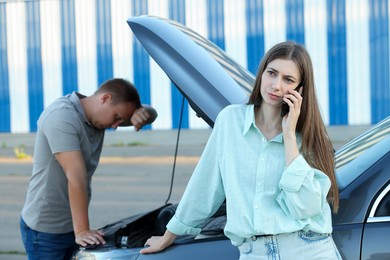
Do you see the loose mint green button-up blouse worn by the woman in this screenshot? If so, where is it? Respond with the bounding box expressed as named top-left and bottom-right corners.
top-left (167, 104), bottom-right (332, 246)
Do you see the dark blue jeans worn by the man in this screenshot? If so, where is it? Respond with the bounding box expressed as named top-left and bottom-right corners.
top-left (20, 218), bottom-right (78, 260)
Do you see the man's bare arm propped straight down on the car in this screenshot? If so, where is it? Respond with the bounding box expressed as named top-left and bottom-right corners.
top-left (55, 151), bottom-right (105, 246)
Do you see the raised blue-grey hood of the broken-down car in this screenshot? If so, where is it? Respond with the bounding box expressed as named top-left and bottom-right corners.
top-left (127, 16), bottom-right (254, 127)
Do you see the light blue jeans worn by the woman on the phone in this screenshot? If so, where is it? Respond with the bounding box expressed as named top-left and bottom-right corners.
top-left (238, 231), bottom-right (342, 260)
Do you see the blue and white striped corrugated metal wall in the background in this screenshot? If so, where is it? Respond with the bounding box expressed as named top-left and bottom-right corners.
top-left (0, 0), bottom-right (390, 133)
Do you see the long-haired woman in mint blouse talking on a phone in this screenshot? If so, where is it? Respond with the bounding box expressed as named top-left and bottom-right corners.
top-left (141, 42), bottom-right (341, 259)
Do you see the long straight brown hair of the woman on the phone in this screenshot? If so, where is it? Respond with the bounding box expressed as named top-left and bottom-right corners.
top-left (248, 41), bottom-right (339, 212)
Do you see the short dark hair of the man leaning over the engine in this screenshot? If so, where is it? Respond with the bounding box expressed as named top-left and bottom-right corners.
top-left (95, 78), bottom-right (141, 108)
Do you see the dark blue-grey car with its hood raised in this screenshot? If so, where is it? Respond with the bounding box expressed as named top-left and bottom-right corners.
top-left (74, 16), bottom-right (390, 260)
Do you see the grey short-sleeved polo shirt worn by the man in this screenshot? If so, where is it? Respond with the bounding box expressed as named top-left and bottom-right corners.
top-left (22, 92), bottom-right (104, 234)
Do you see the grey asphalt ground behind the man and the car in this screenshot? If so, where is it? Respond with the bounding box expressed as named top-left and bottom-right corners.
top-left (0, 126), bottom-right (369, 260)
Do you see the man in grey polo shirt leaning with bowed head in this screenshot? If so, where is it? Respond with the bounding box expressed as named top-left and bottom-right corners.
top-left (20, 79), bottom-right (157, 259)
